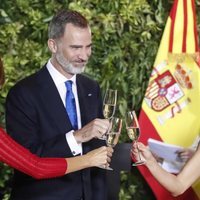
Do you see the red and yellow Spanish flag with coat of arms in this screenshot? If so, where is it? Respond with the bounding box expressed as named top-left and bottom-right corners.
top-left (138, 0), bottom-right (200, 200)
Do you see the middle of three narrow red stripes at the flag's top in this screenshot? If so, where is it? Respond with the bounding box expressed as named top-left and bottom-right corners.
top-left (182, 0), bottom-right (188, 53)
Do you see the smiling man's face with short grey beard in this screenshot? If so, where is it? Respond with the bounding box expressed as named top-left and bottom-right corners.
top-left (55, 24), bottom-right (92, 75)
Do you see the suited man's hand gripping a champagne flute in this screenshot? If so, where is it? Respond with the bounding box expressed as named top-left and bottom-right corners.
top-left (74, 119), bottom-right (109, 143)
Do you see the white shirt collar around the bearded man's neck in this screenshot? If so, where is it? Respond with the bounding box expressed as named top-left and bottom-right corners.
top-left (47, 59), bottom-right (76, 86)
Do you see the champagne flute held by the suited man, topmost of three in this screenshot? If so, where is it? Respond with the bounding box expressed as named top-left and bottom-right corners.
top-left (99, 89), bottom-right (117, 140)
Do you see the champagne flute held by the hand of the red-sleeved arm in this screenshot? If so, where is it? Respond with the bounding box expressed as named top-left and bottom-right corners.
top-left (105, 117), bottom-right (122, 170)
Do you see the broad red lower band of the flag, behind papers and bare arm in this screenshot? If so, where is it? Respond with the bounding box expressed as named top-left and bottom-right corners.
top-left (138, 109), bottom-right (199, 200)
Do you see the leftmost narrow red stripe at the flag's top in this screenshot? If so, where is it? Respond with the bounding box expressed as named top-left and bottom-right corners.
top-left (169, 0), bottom-right (178, 53)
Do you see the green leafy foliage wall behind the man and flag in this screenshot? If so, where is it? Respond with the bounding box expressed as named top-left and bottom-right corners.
top-left (0, 0), bottom-right (200, 200)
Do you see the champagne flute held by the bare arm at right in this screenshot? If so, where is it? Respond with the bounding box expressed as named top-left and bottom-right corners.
top-left (126, 111), bottom-right (144, 166)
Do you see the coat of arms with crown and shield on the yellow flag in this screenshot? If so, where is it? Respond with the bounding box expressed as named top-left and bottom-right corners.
top-left (144, 62), bottom-right (194, 125)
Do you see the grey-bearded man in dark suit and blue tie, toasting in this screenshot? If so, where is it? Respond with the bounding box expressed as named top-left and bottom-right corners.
top-left (6, 10), bottom-right (109, 200)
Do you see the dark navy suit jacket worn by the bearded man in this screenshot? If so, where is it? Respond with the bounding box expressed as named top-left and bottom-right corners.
top-left (6, 66), bottom-right (106, 200)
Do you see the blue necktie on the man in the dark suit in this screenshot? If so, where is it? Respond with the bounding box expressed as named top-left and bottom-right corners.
top-left (65, 81), bottom-right (78, 130)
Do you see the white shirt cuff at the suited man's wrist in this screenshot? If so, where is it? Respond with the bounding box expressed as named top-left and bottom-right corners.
top-left (65, 130), bottom-right (83, 156)
